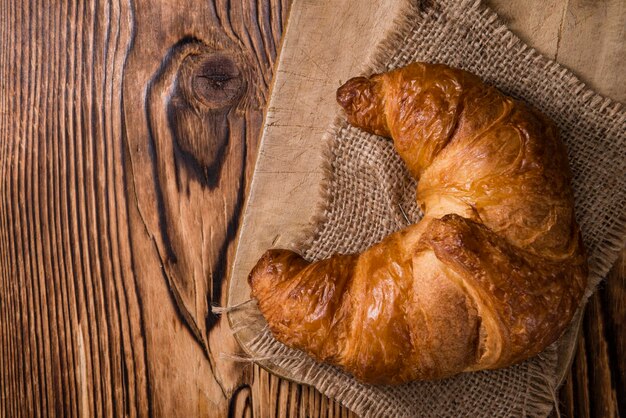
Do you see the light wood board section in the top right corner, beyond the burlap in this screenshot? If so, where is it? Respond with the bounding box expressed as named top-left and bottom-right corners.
top-left (485, 0), bottom-right (626, 103)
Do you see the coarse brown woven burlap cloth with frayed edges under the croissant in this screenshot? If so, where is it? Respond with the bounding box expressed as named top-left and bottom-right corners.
top-left (235, 1), bottom-right (626, 417)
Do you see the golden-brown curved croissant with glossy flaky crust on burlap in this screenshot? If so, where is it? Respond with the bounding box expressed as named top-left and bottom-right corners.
top-left (248, 63), bottom-right (587, 384)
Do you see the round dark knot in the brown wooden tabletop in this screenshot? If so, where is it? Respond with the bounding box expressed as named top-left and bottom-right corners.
top-left (182, 52), bottom-right (246, 109)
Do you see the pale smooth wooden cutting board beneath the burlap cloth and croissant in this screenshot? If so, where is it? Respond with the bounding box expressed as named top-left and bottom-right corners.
top-left (229, 0), bottom-right (626, 414)
